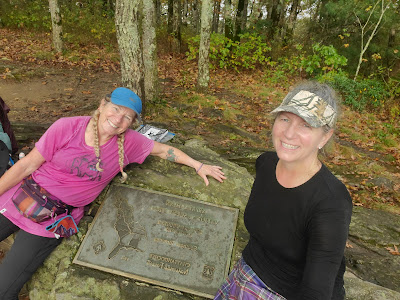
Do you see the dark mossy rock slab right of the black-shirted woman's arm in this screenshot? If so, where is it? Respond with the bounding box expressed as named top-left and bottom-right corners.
top-left (345, 206), bottom-right (400, 292)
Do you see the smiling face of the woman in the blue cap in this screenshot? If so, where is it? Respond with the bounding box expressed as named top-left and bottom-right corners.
top-left (98, 100), bottom-right (136, 139)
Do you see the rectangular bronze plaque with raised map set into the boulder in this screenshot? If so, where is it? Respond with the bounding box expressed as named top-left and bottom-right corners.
top-left (74, 185), bottom-right (238, 298)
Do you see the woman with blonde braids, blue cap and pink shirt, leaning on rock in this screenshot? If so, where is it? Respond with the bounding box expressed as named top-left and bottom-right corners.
top-left (0, 87), bottom-right (225, 300)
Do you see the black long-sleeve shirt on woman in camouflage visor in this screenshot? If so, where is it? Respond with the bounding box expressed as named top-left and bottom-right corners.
top-left (243, 152), bottom-right (352, 300)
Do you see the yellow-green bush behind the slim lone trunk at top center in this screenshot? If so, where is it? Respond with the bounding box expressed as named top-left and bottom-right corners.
top-left (186, 33), bottom-right (271, 71)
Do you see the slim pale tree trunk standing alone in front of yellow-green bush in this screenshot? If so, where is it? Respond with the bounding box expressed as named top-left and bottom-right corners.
top-left (197, 0), bottom-right (213, 93)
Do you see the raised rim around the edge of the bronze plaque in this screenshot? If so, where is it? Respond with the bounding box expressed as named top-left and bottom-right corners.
top-left (72, 183), bottom-right (239, 299)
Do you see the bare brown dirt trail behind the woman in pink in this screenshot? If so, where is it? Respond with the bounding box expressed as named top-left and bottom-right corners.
top-left (0, 63), bottom-right (120, 124)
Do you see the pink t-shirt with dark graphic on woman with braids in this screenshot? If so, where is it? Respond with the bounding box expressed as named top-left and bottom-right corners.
top-left (0, 117), bottom-right (154, 237)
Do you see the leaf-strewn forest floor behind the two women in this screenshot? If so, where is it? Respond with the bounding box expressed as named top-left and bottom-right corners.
top-left (0, 29), bottom-right (400, 219)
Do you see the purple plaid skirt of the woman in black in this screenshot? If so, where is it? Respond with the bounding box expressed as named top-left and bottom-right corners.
top-left (214, 257), bottom-right (286, 300)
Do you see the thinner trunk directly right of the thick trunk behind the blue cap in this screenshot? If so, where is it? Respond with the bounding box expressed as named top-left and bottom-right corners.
top-left (143, 0), bottom-right (158, 101)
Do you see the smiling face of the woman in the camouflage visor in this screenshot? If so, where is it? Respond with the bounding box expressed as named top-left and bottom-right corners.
top-left (272, 112), bottom-right (333, 165)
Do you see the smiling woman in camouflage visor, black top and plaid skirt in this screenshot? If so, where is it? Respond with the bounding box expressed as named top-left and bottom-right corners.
top-left (215, 82), bottom-right (352, 300)
